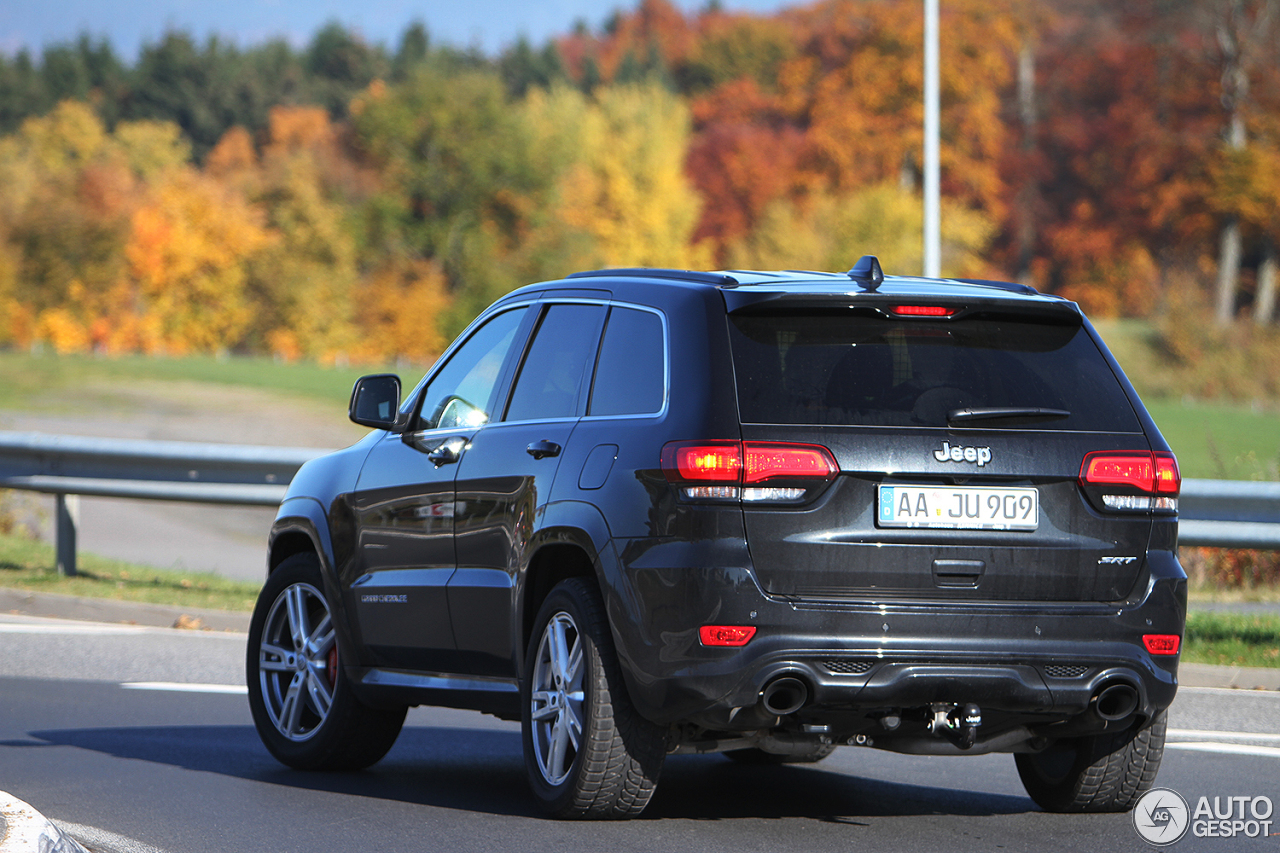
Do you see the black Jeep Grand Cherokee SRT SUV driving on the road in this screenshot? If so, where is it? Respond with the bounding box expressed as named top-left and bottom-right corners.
top-left (247, 256), bottom-right (1187, 817)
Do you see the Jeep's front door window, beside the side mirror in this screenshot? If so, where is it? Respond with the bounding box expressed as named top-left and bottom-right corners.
top-left (417, 309), bottom-right (525, 429)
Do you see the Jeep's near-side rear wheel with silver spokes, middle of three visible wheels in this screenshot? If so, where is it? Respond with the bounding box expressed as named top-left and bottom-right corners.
top-left (521, 578), bottom-right (667, 820)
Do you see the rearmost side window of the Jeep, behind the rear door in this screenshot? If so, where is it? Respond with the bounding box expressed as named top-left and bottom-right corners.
top-left (588, 307), bottom-right (667, 415)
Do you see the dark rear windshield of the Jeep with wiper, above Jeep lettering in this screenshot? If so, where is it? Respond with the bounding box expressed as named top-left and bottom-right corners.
top-left (730, 311), bottom-right (1142, 432)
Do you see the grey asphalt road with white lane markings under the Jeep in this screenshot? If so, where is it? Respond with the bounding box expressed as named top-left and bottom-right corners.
top-left (0, 616), bottom-right (1280, 853)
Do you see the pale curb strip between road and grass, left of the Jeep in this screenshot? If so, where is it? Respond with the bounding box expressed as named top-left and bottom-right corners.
top-left (0, 588), bottom-right (250, 634)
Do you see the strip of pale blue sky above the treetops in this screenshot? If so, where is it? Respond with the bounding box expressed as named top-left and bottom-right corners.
top-left (0, 0), bottom-right (795, 63)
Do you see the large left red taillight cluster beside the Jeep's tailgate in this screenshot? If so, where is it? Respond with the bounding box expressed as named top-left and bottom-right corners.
top-left (662, 441), bottom-right (840, 503)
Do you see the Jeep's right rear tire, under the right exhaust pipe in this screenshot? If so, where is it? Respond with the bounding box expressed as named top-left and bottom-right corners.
top-left (1014, 712), bottom-right (1166, 812)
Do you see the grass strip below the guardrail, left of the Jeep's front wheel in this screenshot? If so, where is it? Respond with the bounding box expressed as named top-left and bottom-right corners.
top-left (0, 535), bottom-right (260, 611)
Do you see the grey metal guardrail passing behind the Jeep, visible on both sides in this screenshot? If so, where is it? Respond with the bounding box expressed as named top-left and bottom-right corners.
top-left (0, 432), bottom-right (1280, 574)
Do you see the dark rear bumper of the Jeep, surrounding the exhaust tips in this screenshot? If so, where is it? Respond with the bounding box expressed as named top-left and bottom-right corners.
top-left (613, 537), bottom-right (1187, 733)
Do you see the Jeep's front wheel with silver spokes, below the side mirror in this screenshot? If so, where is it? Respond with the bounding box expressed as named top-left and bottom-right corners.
top-left (244, 553), bottom-right (407, 770)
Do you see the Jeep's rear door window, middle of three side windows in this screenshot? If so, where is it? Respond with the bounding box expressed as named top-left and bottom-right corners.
top-left (507, 305), bottom-right (604, 420)
